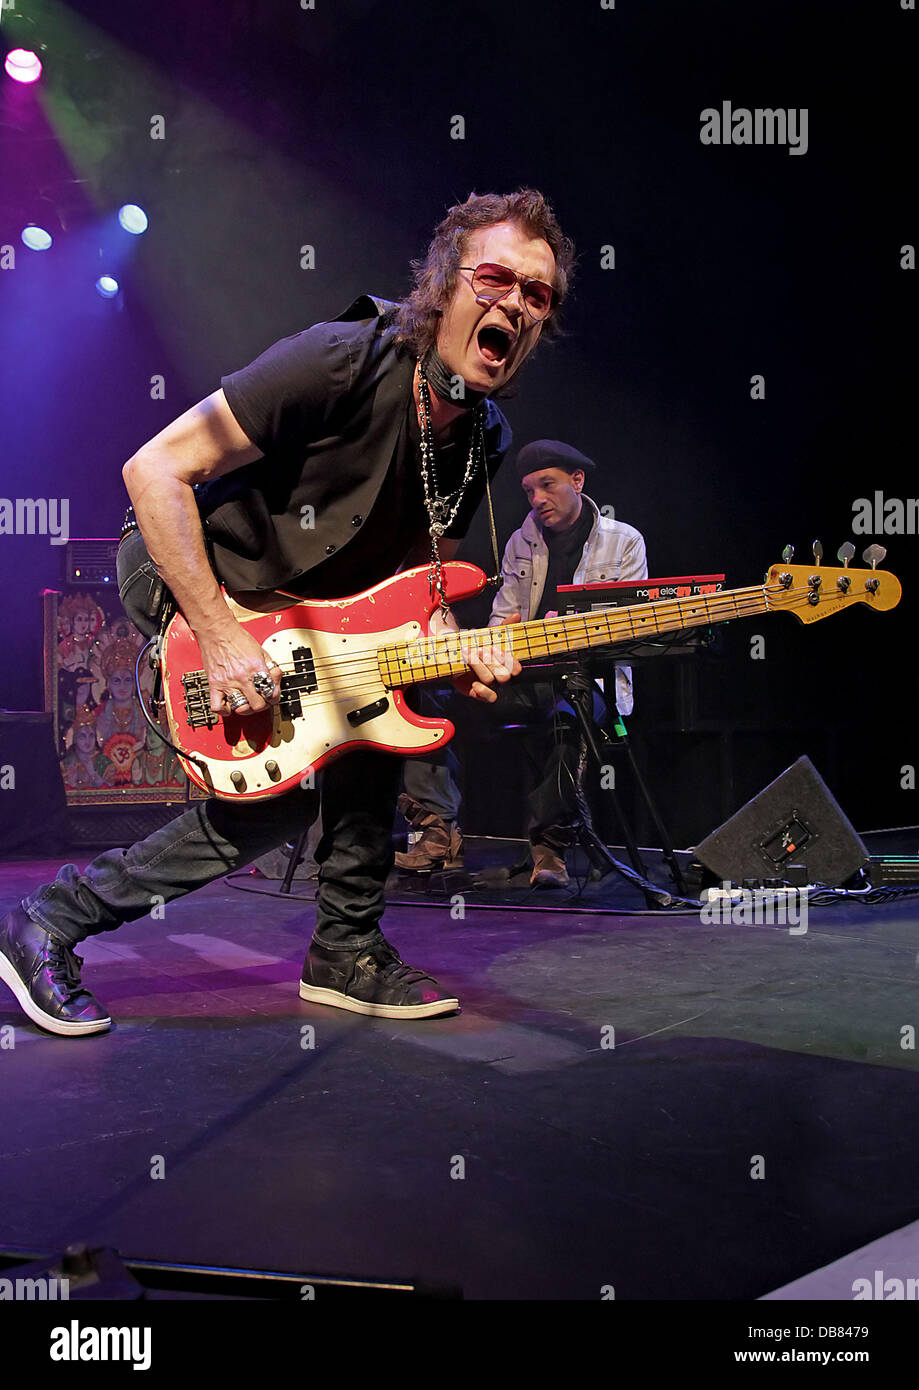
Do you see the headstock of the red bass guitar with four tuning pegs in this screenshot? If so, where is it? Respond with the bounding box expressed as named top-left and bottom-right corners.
top-left (766, 541), bottom-right (902, 623)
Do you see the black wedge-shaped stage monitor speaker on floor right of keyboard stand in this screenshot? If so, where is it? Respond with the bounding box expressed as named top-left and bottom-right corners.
top-left (695, 758), bottom-right (869, 887)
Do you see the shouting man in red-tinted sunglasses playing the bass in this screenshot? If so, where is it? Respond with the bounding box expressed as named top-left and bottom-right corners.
top-left (0, 189), bottom-right (574, 1036)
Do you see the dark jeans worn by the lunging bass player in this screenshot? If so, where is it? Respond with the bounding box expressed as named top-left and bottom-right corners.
top-left (22, 532), bottom-right (402, 948)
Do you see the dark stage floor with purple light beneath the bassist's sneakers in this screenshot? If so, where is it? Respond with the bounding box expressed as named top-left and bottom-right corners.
top-left (0, 834), bottom-right (919, 1300)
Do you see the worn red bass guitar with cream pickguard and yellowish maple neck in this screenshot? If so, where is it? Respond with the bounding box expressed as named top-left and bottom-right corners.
top-left (160, 547), bottom-right (901, 801)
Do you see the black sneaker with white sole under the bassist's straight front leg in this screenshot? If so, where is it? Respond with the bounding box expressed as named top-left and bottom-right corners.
top-left (300, 941), bottom-right (459, 1019)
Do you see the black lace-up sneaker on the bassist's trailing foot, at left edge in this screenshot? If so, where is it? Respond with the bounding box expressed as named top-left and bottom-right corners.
top-left (0, 908), bottom-right (111, 1037)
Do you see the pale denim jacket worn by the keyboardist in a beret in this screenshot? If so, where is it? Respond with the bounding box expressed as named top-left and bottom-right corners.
top-left (488, 492), bottom-right (648, 714)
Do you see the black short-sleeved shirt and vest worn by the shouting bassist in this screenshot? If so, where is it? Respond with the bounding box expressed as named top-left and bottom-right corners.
top-left (196, 296), bottom-right (510, 598)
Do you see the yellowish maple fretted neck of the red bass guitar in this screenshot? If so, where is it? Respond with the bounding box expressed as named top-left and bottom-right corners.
top-left (380, 584), bottom-right (772, 688)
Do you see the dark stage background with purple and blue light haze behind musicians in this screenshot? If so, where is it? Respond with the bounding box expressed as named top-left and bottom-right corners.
top-left (0, 0), bottom-right (919, 842)
